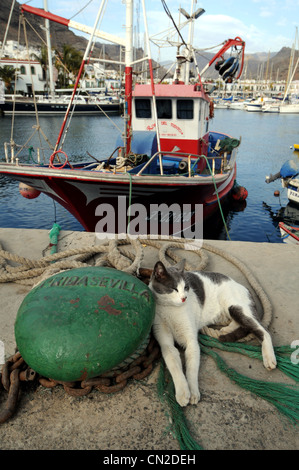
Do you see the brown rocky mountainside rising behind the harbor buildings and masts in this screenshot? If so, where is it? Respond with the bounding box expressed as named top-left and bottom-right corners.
top-left (0, 0), bottom-right (299, 80)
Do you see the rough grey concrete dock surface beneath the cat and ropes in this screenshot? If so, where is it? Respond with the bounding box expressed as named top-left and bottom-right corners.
top-left (0, 229), bottom-right (299, 453)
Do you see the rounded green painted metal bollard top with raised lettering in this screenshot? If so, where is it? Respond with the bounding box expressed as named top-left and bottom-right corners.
top-left (15, 267), bottom-right (155, 381)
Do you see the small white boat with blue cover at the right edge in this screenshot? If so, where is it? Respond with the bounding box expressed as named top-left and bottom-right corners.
top-left (266, 159), bottom-right (299, 204)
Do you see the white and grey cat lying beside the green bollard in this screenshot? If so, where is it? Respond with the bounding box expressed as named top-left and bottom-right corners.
top-left (145, 260), bottom-right (276, 406)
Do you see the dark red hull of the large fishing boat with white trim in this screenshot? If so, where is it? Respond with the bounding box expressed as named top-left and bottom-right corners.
top-left (0, 164), bottom-right (236, 238)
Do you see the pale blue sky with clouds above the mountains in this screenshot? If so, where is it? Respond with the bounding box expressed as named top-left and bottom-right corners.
top-left (19, 0), bottom-right (299, 61)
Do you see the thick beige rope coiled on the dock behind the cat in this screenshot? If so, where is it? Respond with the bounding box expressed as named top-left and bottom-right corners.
top-left (0, 236), bottom-right (272, 334)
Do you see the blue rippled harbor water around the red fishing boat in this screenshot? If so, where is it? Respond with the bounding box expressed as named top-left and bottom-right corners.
top-left (0, 109), bottom-right (299, 243)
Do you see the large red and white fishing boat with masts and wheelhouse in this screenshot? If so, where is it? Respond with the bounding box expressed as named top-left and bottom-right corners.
top-left (0, 0), bottom-right (245, 238)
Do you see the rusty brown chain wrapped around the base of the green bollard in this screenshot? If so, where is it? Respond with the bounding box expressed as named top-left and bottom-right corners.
top-left (0, 336), bottom-right (160, 424)
